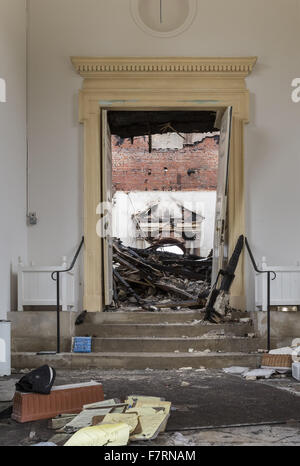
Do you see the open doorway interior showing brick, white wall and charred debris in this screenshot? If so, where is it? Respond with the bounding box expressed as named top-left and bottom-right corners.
top-left (101, 107), bottom-right (232, 308)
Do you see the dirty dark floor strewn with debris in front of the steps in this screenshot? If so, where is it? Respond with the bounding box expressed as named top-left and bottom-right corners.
top-left (0, 369), bottom-right (300, 446)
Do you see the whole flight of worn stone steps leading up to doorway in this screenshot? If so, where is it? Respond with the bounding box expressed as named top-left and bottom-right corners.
top-left (12, 310), bottom-right (264, 370)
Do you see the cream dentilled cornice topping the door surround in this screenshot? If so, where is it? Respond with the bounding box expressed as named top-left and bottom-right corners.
top-left (71, 57), bottom-right (257, 78)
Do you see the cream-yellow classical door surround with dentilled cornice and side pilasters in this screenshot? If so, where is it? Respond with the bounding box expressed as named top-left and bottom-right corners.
top-left (71, 57), bottom-right (257, 312)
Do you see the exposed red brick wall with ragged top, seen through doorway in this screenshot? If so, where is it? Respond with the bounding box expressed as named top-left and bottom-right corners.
top-left (113, 136), bottom-right (219, 191)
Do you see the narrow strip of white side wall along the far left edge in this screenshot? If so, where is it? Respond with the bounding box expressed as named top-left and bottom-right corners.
top-left (0, 0), bottom-right (27, 319)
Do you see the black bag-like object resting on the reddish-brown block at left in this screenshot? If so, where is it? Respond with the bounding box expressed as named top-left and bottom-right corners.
top-left (16, 365), bottom-right (56, 395)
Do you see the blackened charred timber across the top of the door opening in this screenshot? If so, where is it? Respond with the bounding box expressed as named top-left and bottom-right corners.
top-left (108, 111), bottom-right (218, 139)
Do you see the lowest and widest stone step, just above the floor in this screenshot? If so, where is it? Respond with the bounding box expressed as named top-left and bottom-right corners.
top-left (12, 352), bottom-right (261, 370)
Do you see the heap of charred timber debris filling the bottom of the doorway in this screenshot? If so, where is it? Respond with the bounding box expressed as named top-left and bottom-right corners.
top-left (109, 238), bottom-right (212, 311)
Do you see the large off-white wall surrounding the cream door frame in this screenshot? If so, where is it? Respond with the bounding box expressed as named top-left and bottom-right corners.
top-left (29, 0), bottom-right (300, 308)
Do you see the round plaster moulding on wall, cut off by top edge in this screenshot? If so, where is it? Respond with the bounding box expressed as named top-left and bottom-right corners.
top-left (130, 0), bottom-right (197, 38)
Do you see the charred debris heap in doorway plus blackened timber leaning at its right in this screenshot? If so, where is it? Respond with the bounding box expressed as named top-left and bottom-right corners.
top-left (106, 235), bottom-right (245, 323)
